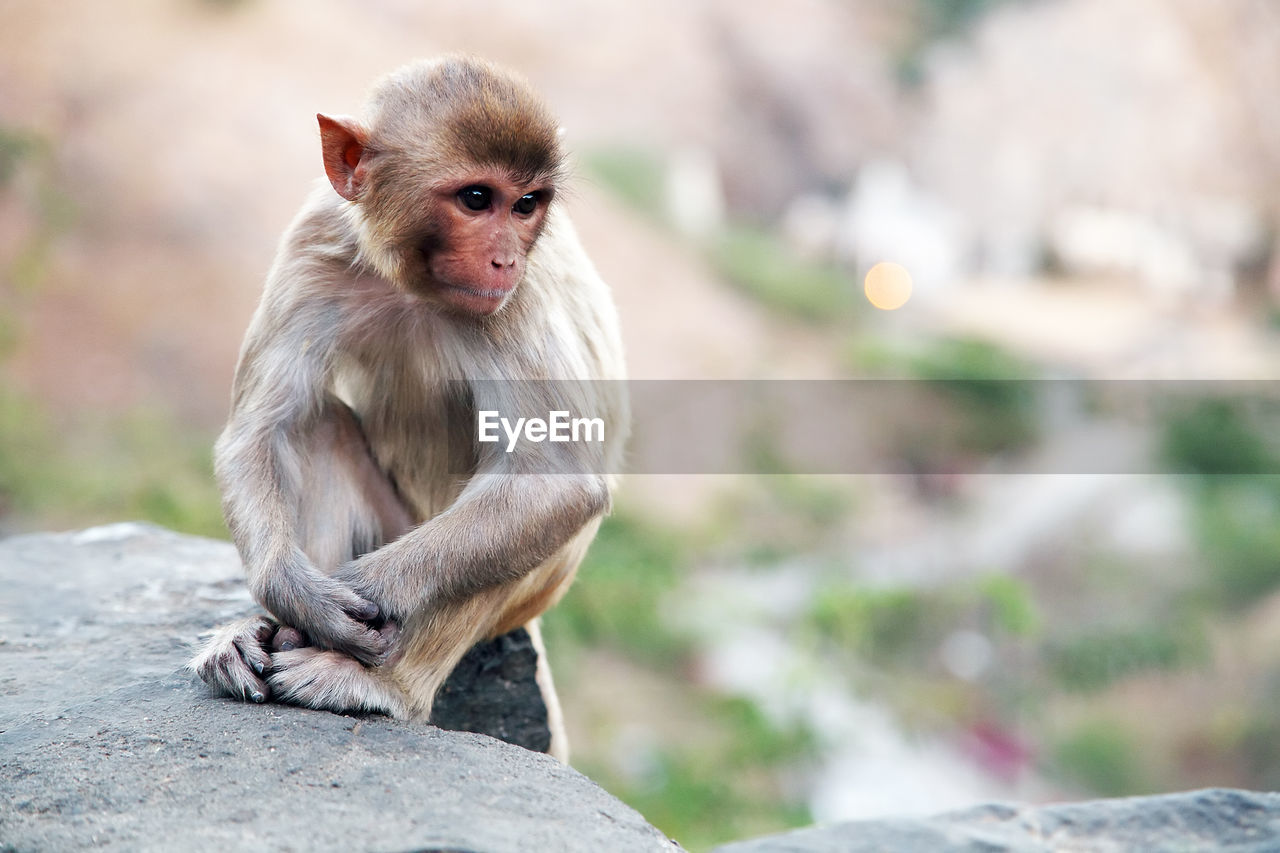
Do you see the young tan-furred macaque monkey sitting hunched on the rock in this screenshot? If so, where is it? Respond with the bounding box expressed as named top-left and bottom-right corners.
top-left (192, 58), bottom-right (627, 752)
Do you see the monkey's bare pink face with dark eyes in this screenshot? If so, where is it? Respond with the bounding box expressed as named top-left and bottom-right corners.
top-left (426, 174), bottom-right (552, 316)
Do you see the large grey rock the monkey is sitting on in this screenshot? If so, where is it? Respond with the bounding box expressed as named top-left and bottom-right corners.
top-left (0, 524), bottom-right (677, 852)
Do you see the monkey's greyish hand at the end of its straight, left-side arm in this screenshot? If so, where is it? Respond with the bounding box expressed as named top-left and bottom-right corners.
top-left (252, 566), bottom-right (390, 666)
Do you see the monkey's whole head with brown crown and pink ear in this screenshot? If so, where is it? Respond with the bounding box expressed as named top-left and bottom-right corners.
top-left (316, 56), bottom-right (563, 316)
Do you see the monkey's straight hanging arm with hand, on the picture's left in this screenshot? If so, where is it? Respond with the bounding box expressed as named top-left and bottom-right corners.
top-left (215, 292), bottom-right (388, 663)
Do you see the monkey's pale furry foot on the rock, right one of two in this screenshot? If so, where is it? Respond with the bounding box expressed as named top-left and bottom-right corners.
top-left (268, 648), bottom-right (406, 717)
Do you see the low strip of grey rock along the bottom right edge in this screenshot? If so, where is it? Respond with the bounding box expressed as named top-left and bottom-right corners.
top-left (714, 788), bottom-right (1280, 853)
